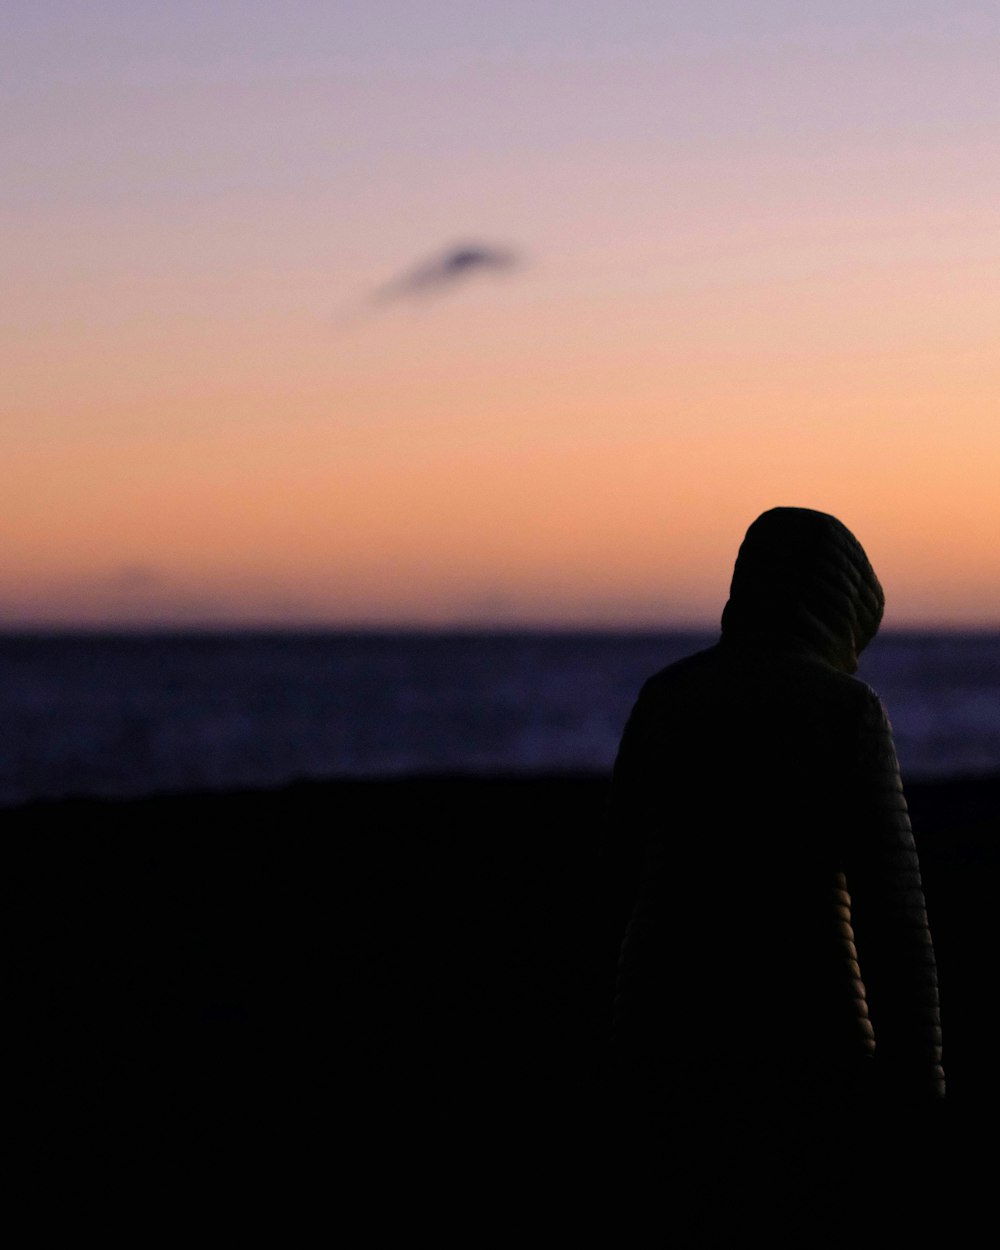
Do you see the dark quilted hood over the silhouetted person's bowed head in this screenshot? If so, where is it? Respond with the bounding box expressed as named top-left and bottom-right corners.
top-left (723, 508), bottom-right (885, 673)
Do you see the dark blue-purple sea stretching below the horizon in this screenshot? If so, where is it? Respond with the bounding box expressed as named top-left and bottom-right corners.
top-left (0, 633), bottom-right (1000, 805)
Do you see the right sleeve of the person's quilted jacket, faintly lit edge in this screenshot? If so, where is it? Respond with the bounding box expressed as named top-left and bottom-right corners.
top-left (845, 691), bottom-right (945, 1100)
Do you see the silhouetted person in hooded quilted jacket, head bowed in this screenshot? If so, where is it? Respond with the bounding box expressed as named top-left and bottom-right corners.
top-left (604, 508), bottom-right (944, 1244)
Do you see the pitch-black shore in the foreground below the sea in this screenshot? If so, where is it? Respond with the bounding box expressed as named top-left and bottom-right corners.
top-left (7, 778), bottom-right (1000, 1245)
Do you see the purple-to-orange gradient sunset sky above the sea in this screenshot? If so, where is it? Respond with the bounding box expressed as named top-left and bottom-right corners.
top-left (7, 0), bottom-right (1000, 628)
